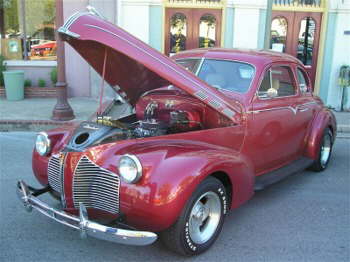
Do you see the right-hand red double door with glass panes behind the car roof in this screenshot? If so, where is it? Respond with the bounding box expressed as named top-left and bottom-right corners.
top-left (271, 11), bottom-right (322, 84)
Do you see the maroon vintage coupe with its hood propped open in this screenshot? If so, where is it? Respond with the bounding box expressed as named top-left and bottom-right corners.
top-left (17, 8), bottom-right (337, 255)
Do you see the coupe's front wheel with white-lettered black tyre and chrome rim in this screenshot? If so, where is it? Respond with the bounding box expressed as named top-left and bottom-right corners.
top-left (161, 177), bottom-right (228, 256)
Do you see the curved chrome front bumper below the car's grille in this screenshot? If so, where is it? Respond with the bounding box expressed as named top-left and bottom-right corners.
top-left (17, 181), bottom-right (157, 246)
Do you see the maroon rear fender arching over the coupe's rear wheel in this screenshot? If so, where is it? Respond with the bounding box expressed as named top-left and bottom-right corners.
top-left (305, 108), bottom-right (337, 160)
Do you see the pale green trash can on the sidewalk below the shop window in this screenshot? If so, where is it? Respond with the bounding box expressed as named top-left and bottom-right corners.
top-left (2, 70), bottom-right (24, 101)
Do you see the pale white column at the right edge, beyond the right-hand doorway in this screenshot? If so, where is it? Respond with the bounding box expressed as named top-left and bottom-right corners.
top-left (324, 0), bottom-right (350, 110)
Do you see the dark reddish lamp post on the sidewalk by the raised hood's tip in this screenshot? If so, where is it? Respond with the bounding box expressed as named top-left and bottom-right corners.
top-left (51, 0), bottom-right (75, 121)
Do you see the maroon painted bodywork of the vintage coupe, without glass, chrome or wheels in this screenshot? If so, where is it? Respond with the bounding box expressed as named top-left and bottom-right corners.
top-left (33, 15), bottom-right (336, 231)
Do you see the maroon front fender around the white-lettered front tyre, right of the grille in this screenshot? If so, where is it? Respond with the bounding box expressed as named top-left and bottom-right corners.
top-left (112, 140), bottom-right (254, 231)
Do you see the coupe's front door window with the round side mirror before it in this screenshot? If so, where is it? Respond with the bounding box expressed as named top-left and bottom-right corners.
top-left (258, 66), bottom-right (296, 98)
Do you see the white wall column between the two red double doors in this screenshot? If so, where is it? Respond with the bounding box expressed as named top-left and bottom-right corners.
top-left (233, 0), bottom-right (267, 48)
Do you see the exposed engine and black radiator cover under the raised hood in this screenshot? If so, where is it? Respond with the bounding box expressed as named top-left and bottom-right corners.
top-left (65, 97), bottom-right (202, 152)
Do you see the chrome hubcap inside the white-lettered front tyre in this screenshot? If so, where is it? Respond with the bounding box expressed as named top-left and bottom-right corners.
top-left (189, 192), bottom-right (222, 244)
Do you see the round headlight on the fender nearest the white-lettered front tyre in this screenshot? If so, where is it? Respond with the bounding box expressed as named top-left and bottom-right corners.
top-left (118, 155), bottom-right (142, 183)
